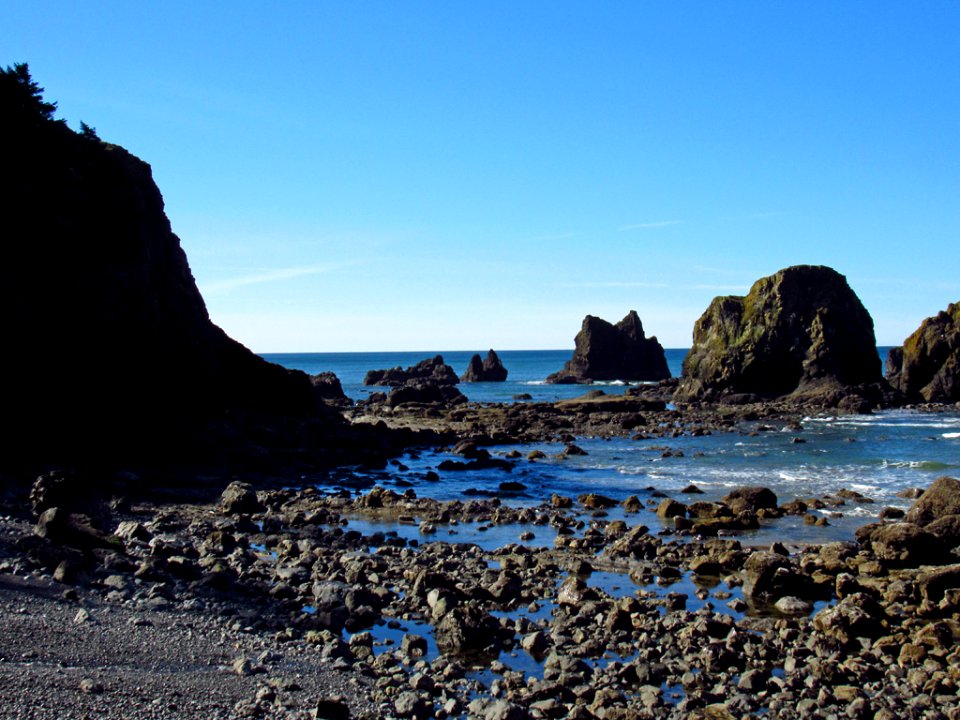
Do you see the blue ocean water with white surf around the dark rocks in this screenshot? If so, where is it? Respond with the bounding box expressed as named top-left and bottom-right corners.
top-left (266, 348), bottom-right (960, 547)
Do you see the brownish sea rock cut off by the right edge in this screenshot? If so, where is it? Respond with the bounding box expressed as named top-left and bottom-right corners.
top-left (887, 303), bottom-right (960, 402)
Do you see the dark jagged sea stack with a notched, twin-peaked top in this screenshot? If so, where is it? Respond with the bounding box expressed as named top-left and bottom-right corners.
top-left (547, 310), bottom-right (670, 385)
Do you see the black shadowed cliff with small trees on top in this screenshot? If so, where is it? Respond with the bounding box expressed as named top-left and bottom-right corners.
top-left (0, 69), bottom-right (317, 457)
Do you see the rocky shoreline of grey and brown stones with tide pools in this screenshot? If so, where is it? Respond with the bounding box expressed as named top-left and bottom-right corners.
top-left (0, 436), bottom-right (960, 720)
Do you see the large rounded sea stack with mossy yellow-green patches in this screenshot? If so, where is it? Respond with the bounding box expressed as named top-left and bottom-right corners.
top-left (674, 265), bottom-right (882, 404)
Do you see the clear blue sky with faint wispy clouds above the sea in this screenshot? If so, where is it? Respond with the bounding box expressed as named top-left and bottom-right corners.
top-left (0, 0), bottom-right (960, 352)
